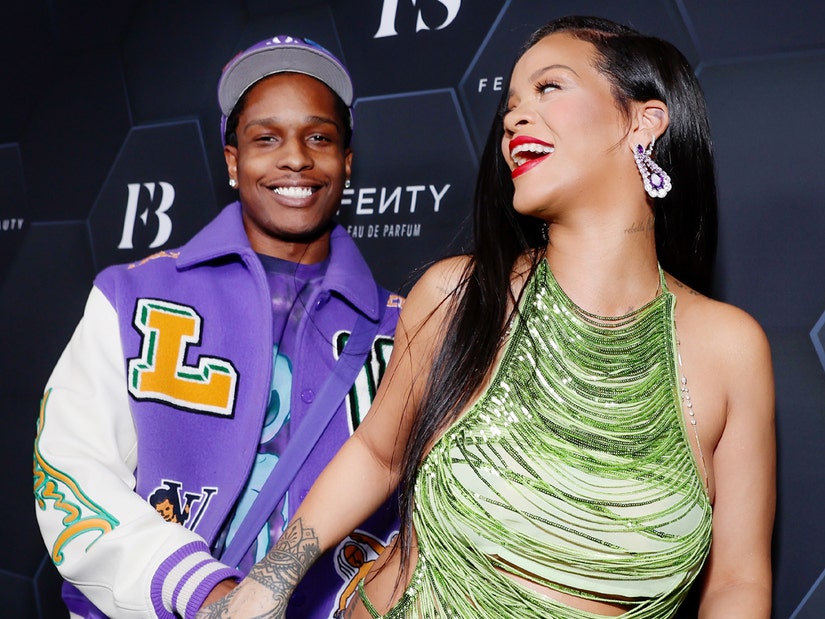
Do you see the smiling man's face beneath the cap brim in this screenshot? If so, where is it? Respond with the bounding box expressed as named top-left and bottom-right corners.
top-left (224, 73), bottom-right (352, 262)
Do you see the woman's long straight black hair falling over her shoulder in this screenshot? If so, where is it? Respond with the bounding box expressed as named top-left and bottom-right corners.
top-left (392, 17), bottom-right (717, 576)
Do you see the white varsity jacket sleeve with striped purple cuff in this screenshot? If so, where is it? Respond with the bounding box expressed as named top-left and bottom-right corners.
top-left (34, 288), bottom-right (240, 618)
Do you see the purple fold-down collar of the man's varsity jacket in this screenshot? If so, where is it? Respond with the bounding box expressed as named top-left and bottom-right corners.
top-left (177, 202), bottom-right (381, 320)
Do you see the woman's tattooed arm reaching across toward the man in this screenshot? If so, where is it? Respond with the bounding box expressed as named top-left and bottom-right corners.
top-left (198, 259), bottom-right (466, 619)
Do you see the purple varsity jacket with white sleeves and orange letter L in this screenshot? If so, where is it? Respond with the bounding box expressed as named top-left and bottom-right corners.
top-left (35, 203), bottom-right (400, 618)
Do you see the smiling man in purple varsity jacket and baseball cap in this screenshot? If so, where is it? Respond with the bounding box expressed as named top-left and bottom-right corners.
top-left (34, 37), bottom-right (400, 618)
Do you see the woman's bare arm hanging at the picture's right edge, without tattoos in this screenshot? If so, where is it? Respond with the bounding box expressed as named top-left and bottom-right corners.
top-left (699, 308), bottom-right (776, 619)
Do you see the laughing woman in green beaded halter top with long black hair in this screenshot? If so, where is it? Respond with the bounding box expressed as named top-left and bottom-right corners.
top-left (198, 17), bottom-right (775, 619)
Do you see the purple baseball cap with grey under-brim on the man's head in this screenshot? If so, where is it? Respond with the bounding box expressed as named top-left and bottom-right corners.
top-left (218, 35), bottom-right (352, 140)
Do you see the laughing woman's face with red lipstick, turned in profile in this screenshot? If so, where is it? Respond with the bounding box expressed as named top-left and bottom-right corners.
top-left (501, 33), bottom-right (632, 221)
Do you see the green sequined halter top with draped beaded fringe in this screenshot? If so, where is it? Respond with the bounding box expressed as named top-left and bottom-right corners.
top-left (362, 262), bottom-right (711, 619)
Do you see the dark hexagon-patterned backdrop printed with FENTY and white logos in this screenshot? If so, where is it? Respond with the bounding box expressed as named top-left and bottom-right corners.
top-left (0, 0), bottom-right (825, 619)
